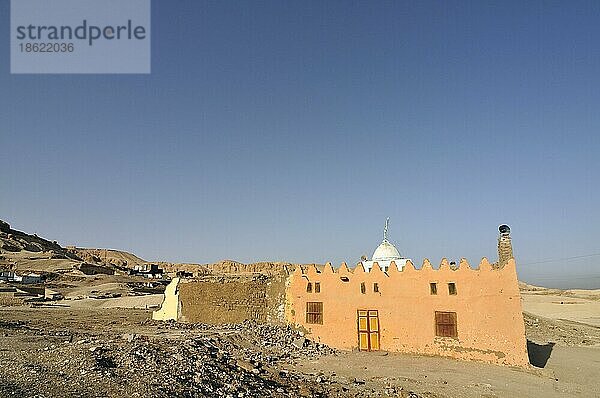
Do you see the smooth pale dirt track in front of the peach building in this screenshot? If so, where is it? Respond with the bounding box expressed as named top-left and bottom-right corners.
top-left (288, 346), bottom-right (600, 398)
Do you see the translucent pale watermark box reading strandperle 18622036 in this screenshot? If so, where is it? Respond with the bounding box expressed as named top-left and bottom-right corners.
top-left (10, 0), bottom-right (151, 73)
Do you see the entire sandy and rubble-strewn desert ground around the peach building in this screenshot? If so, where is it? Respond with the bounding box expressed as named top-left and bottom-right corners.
top-left (0, 288), bottom-right (600, 397)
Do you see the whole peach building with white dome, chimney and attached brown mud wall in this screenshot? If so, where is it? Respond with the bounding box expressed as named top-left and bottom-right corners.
top-left (153, 222), bottom-right (528, 366)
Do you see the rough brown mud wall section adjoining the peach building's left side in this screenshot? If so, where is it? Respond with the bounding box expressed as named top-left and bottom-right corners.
top-left (178, 275), bottom-right (286, 324)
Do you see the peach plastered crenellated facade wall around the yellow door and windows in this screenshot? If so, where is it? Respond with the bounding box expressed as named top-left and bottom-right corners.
top-left (286, 258), bottom-right (528, 366)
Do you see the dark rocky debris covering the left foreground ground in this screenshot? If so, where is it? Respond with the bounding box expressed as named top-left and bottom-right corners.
top-left (0, 321), bottom-right (426, 398)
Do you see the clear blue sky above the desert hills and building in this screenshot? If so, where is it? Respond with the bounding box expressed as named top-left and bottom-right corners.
top-left (0, 0), bottom-right (600, 288)
